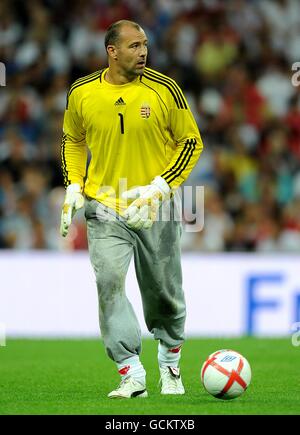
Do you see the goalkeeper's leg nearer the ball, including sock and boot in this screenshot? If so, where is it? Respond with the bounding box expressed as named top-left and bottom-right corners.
top-left (134, 205), bottom-right (186, 394)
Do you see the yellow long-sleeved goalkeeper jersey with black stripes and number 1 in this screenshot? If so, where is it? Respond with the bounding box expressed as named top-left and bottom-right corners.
top-left (61, 68), bottom-right (203, 214)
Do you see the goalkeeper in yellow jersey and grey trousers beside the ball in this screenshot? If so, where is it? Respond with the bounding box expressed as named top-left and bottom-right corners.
top-left (61, 20), bottom-right (203, 398)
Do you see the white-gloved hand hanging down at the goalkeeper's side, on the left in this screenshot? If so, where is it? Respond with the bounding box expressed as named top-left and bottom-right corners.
top-left (60, 183), bottom-right (84, 237)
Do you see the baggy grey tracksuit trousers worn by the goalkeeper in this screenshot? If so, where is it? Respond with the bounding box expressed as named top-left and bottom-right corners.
top-left (85, 200), bottom-right (186, 363)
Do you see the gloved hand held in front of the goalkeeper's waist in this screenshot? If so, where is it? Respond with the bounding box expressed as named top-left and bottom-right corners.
top-left (122, 176), bottom-right (171, 230)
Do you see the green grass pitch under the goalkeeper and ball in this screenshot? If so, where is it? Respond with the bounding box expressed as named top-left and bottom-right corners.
top-left (0, 337), bottom-right (300, 415)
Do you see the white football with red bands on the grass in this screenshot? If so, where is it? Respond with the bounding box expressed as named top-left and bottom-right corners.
top-left (201, 349), bottom-right (251, 400)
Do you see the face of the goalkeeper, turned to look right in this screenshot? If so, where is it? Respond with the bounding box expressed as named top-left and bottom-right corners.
top-left (111, 26), bottom-right (148, 77)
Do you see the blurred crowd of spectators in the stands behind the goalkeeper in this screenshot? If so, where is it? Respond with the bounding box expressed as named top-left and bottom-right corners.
top-left (0, 0), bottom-right (300, 252)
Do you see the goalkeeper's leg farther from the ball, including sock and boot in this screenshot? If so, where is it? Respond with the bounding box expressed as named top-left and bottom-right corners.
top-left (86, 200), bottom-right (145, 397)
